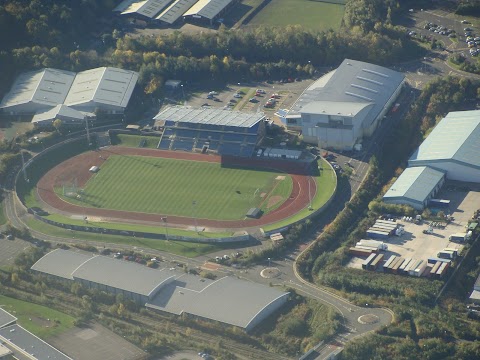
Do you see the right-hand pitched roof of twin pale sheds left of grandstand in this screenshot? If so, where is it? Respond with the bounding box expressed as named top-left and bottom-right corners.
top-left (65, 67), bottom-right (138, 107)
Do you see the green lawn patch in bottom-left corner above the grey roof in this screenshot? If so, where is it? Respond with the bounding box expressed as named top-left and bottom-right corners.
top-left (0, 295), bottom-right (75, 339)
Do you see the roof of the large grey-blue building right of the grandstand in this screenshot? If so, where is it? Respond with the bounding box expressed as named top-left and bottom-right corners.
top-left (291, 59), bottom-right (405, 121)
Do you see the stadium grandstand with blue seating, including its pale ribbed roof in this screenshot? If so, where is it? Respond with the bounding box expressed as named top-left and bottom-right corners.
top-left (154, 106), bottom-right (265, 157)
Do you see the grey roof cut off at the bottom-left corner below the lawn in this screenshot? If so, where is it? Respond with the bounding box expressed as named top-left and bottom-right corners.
top-left (0, 325), bottom-right (72, 360)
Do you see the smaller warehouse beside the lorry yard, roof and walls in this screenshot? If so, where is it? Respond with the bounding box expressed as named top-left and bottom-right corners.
top-left (383, 166), bottom-right (445, 210)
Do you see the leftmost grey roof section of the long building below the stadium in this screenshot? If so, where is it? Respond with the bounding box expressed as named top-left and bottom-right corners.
top-left (32, 249), bottom-right (92, 280)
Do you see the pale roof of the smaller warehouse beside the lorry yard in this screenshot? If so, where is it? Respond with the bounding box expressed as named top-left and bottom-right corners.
top-left (383, 166), bottom-right (445, 203)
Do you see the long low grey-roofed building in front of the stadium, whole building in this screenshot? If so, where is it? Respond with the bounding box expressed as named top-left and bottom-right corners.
top-left (32, 249), bottom-right (289, 331)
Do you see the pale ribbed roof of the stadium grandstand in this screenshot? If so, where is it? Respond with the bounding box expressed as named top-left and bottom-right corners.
top-left (154, 106), bottom-right (265, 128)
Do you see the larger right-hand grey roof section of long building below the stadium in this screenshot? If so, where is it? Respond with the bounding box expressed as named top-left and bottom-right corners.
top-left (147, 274), bottom-right (288, 328)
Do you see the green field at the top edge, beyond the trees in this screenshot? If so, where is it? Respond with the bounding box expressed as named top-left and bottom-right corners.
top-left (249, 0), bottom-right (345, 31)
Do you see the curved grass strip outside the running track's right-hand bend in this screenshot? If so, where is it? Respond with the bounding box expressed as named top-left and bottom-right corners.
top-left (263, 159), bottom-right (337, 231)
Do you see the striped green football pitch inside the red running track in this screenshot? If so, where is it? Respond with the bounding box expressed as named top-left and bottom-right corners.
top-left (67, 155), bottom-right (293, 220)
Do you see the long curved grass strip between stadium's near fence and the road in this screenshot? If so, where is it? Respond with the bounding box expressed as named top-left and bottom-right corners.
top-left (21, 218), bottom-right (244, 257)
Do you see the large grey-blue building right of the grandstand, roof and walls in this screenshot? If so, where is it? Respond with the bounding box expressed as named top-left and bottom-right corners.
top-left (281, 59), bottom-right (405, 150)
